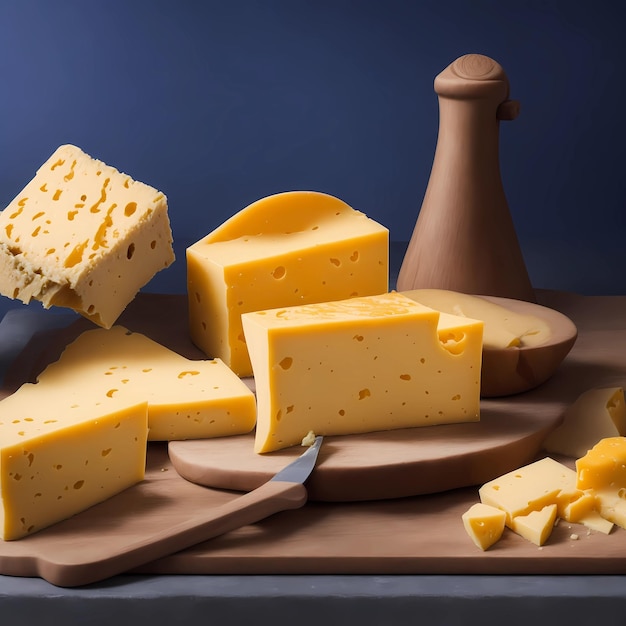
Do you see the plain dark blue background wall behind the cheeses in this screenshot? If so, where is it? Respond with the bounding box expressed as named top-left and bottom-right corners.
top-left (0, 0), bottom-right (626, 293)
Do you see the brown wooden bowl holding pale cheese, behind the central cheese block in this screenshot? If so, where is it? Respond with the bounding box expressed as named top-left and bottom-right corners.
top-left (480, 296), bottom-right (578, 398)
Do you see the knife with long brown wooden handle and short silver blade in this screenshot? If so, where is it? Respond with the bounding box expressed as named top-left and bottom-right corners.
top-left (37, 436), bottom-right (323, 587)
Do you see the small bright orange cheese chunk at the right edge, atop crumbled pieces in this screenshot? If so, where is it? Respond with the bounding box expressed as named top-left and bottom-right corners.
top-left (576, 437), bottom-right (626, 491)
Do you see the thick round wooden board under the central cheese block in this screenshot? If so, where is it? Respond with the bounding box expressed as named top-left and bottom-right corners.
top-left (168, 392), bottom-right (566, 502)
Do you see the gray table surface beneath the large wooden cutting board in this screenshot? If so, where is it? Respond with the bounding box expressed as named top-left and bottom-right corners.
top-left (0, 240), bottom-right (626, 626)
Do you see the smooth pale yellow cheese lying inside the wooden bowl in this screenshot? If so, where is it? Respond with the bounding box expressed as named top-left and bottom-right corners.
top-left (402, 289), bottom-right (551, 349)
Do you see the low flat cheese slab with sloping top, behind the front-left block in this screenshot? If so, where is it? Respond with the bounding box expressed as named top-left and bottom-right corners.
top-left (38, 325), bottom-right (256, 441)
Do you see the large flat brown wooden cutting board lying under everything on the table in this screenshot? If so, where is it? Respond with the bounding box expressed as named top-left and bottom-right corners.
top-left (0, 294), bottom-right (626, 576)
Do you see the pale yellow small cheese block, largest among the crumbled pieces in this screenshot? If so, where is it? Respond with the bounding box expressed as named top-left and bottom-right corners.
top-left (478, 457), bottom-right (585, 528)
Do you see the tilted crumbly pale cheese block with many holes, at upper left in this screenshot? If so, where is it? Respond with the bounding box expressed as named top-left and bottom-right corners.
top-left (0, 145), bottom-right (174, 328)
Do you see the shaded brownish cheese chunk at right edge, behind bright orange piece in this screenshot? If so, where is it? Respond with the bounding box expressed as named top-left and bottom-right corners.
top-left (543, 387), bottom-right (626, 458)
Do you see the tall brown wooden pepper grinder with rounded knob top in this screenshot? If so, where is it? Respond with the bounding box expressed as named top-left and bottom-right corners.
top-left (397, 54), bottom-right (536, 302)
